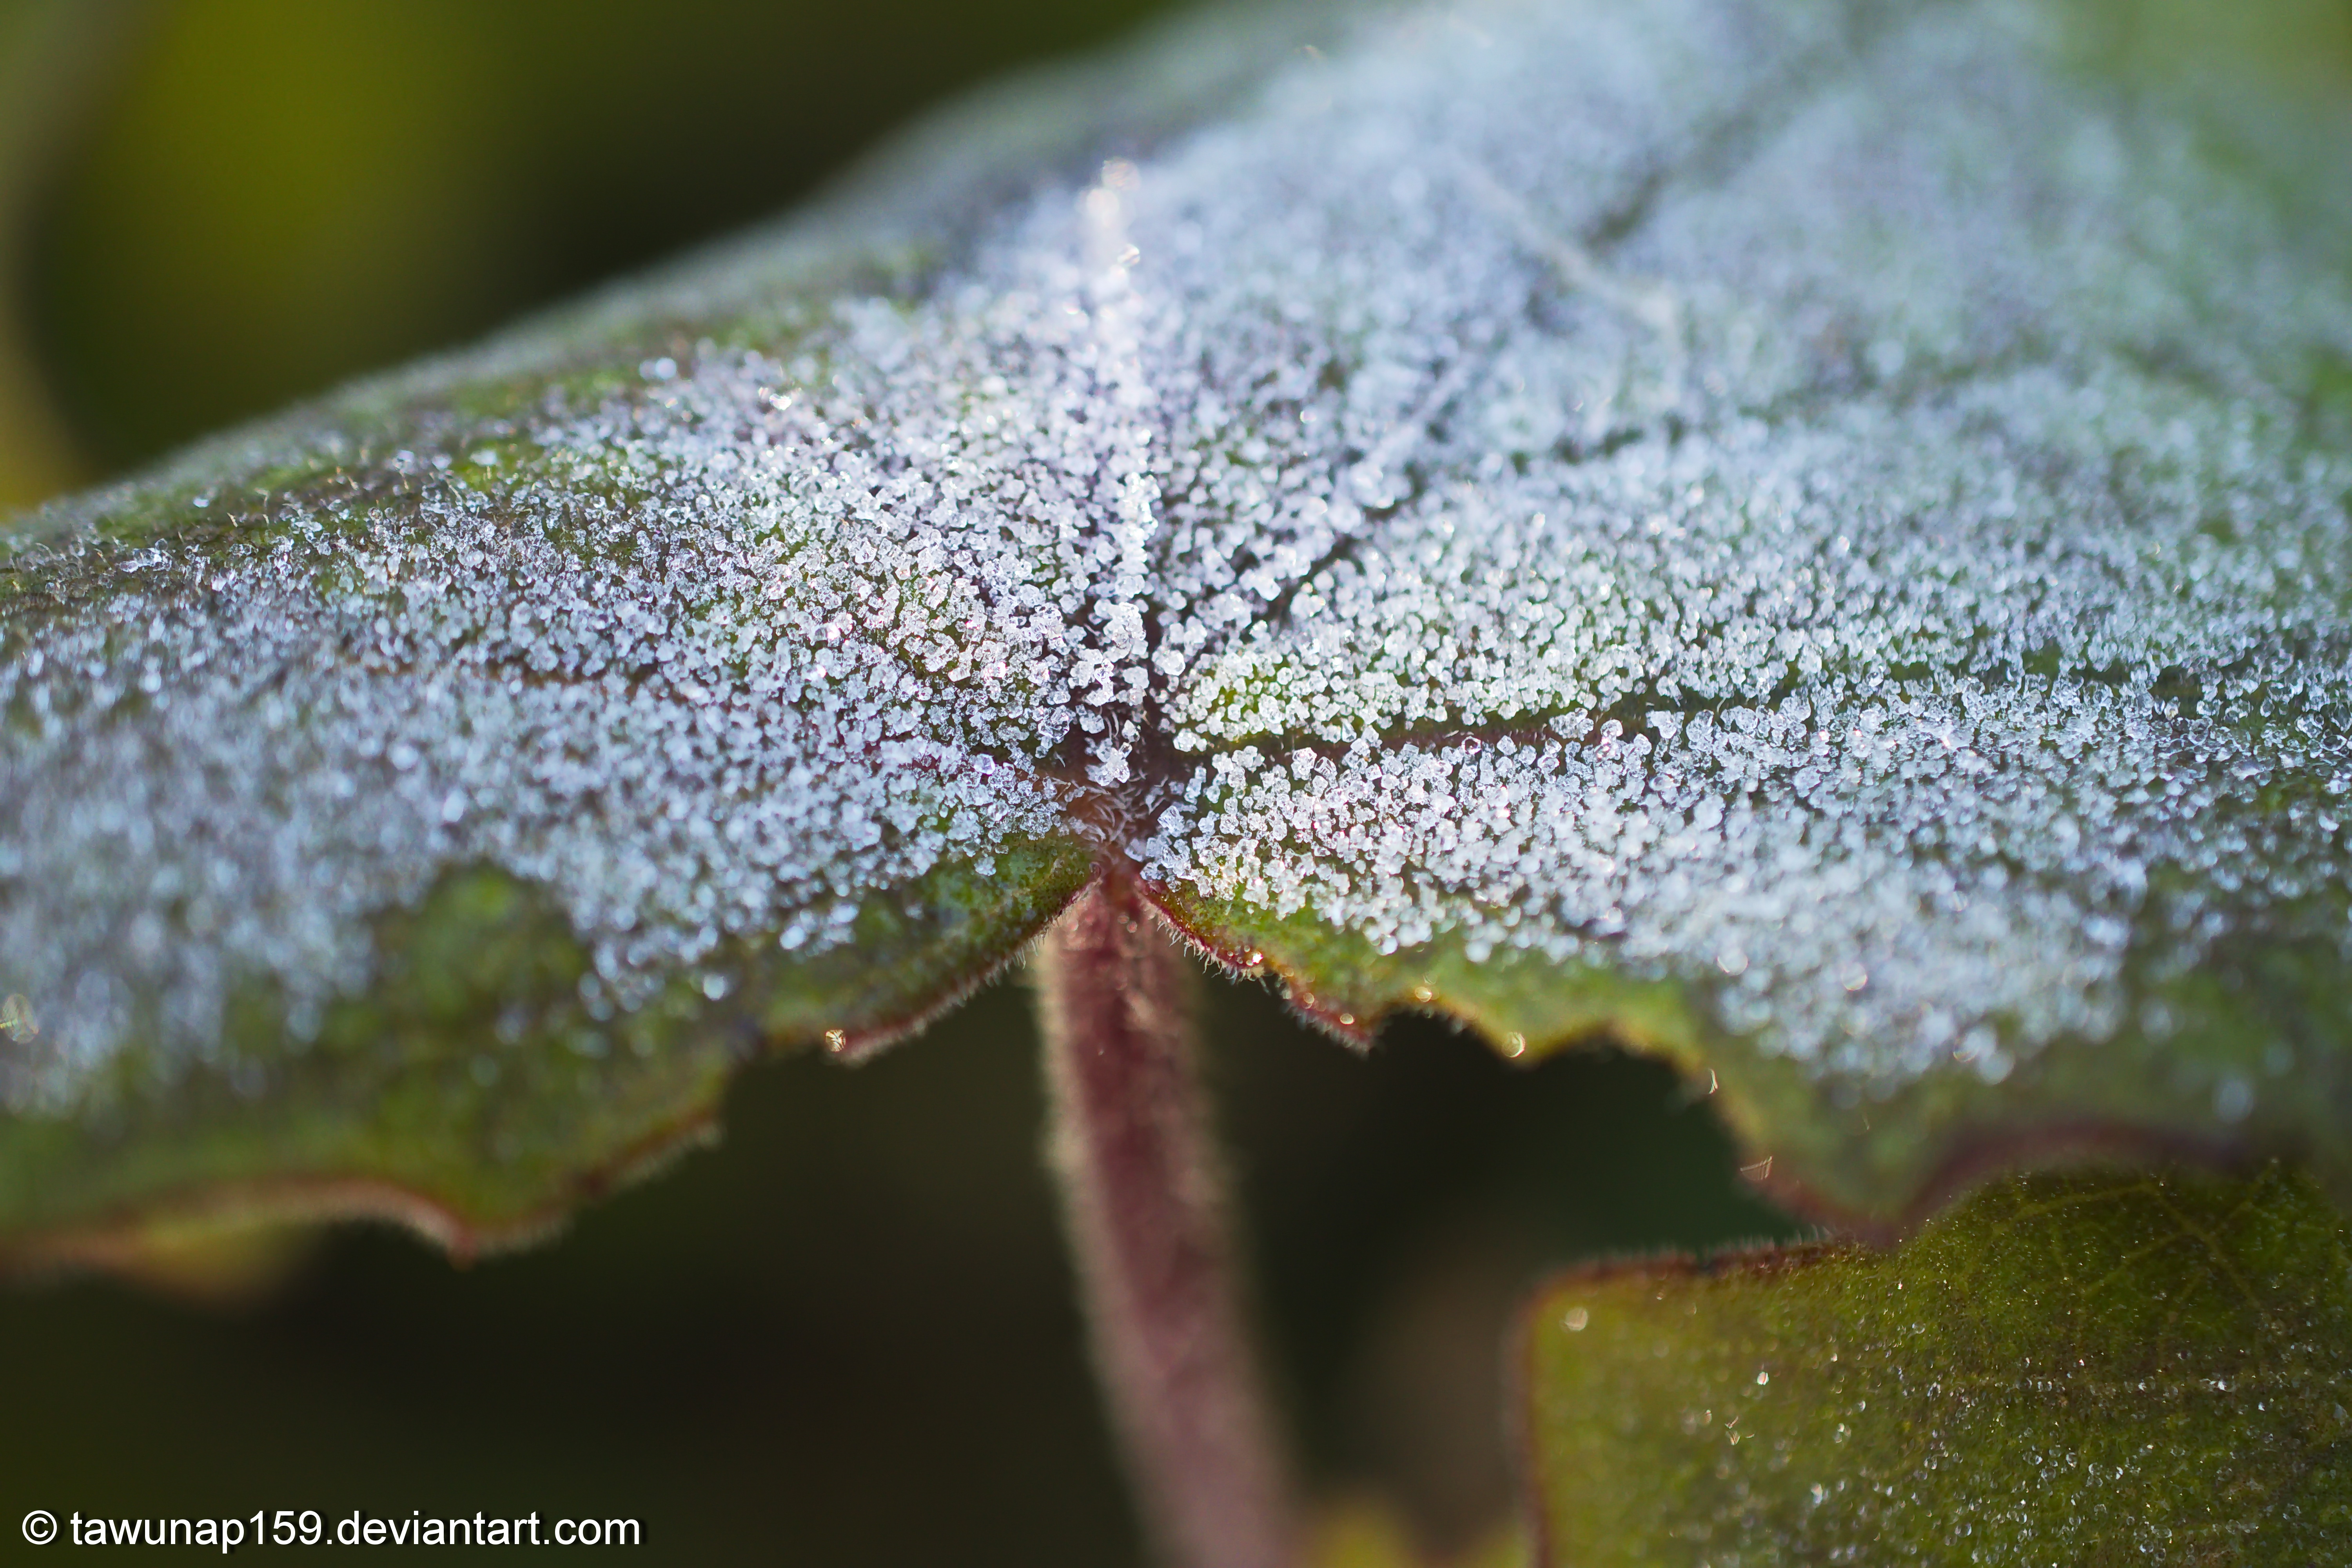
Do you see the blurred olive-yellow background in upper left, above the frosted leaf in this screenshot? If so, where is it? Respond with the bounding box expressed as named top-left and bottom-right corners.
top-left (0, 0), bottom-right (1195, 486)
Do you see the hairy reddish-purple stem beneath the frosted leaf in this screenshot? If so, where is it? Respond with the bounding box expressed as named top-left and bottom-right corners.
top-left (1040, 877), bottom-right (1296, 1568)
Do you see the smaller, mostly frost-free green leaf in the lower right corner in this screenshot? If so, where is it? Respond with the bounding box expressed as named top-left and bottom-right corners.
top-left (1524, 1166), bottom-right (2352, 1568)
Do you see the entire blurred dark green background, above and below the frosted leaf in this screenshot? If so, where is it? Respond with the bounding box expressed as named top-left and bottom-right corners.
top-left (0, 0), bottom-right (1785, 1568)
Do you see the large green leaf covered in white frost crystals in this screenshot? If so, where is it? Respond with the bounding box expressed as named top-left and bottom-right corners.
top-left (0, 0), bottom-right (2352, 1246)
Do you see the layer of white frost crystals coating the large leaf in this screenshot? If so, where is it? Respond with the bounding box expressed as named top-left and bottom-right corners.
top-left (0, 0), bottom-right (2352, 1114)
